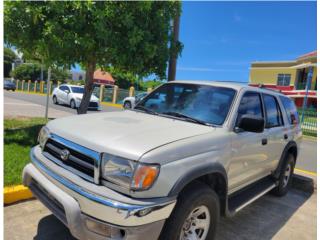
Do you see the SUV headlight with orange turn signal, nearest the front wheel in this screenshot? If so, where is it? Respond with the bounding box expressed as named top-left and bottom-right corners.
top-left (101, 153), bottom-right (159, 190)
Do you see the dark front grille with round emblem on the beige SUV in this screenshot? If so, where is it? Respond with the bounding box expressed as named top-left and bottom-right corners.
top-left (43, 138), bottom-right (94, 181)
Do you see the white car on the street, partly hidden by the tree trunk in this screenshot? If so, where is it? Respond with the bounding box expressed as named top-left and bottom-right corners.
top-left (52, 84), bottom-right (101, 110)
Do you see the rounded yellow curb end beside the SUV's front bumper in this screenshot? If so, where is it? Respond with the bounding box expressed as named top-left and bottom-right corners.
top-left (3, 185), bottom-right (33, 204)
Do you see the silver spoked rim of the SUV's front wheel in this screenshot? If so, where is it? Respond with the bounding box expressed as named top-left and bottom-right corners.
top-left (180, 206), bottom-right (210, 240)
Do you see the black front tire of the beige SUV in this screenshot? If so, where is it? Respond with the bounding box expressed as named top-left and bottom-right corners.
top-left (159, 182), bottom-right (220, 240)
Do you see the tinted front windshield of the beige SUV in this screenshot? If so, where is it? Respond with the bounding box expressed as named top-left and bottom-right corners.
top-left (135, 83), bottom-right (236, 125)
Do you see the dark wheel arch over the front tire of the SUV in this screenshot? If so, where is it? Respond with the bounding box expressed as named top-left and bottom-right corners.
top-left (169, 163), bottom-right (228, 215)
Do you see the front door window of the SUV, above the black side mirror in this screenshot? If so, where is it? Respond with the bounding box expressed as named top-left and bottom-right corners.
top-left (236, 92), bottom-right (263, 125)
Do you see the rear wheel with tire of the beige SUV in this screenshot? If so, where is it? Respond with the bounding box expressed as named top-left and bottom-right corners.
top-left (271, 153), bottom-right (295, 197)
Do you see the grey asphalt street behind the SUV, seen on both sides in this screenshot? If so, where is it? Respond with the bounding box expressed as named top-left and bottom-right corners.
top-left (4, 91), bottom-right (317, 173)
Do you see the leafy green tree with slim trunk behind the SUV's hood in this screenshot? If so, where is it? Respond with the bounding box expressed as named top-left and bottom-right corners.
top-left (4, 1), bottom-right (182, 113)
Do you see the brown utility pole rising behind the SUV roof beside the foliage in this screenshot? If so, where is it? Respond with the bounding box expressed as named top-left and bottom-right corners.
top-left (168, 14), bottom-right (180, 81)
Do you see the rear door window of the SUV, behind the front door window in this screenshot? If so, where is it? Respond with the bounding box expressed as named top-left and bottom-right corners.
top-left (263, 94), bottom-right (283, 128)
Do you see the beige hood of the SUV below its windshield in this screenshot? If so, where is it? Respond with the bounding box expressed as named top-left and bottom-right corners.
top-left (47, 110), bottom-right (215, 160)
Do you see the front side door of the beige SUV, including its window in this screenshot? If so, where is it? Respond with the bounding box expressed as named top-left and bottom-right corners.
top-left (228, 91), bottom-right (268, 193)
